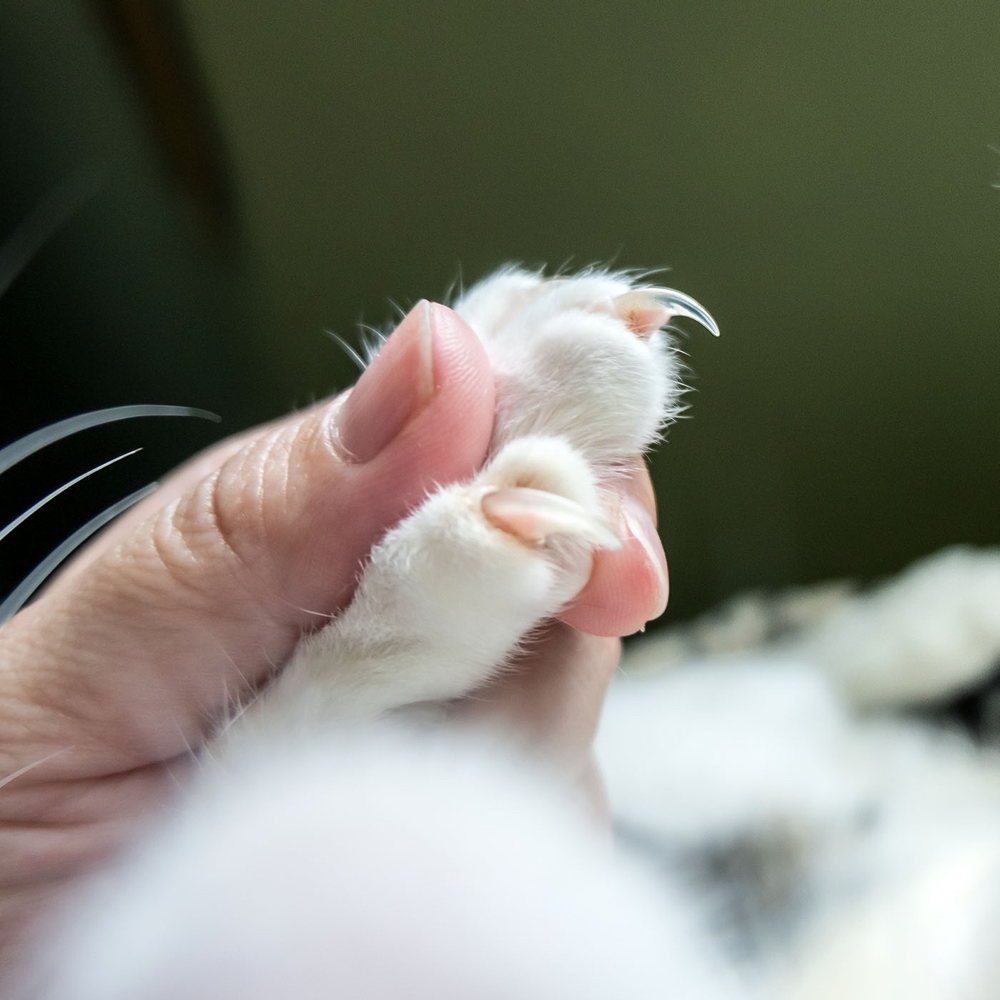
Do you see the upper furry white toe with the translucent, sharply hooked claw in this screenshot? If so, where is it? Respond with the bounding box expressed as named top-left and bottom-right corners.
top-left (455, 270), bottom-right (719, 466)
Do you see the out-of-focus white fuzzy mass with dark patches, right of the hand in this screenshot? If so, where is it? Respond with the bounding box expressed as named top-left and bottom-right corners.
top-left (597, 549), bottom-right (1000, 1000)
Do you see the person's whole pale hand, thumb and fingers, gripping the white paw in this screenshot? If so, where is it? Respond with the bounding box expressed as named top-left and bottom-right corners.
top-left (0, 305), bottom-right (667, 967)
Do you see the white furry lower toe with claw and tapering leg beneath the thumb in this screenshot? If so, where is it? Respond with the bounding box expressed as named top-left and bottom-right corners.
top-left (223, 437), bottom-right (621, 739)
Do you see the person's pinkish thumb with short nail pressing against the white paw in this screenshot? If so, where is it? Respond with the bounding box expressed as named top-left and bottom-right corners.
top-left (0, 302), bottom-right (494, 776)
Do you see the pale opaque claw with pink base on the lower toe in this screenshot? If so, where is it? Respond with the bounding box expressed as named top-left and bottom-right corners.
top-left (480, 486), bottom-right (622, 550)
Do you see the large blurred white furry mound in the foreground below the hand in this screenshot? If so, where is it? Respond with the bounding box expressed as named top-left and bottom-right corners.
top-left (29, 731), bottom-right (744, 1000)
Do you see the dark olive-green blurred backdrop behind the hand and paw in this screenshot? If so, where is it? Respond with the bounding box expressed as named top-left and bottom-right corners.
top-left (0, 0), bottom-right (1000, 620)
